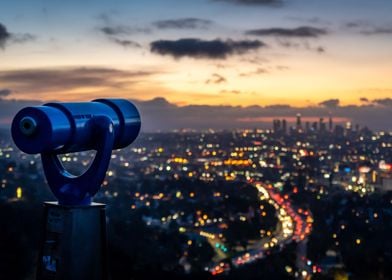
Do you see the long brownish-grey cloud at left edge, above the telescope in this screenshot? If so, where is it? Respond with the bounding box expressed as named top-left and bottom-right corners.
top-left (0, 67), bottom-right (155, 92)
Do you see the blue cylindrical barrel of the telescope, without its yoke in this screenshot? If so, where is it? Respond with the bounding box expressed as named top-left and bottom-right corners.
top-left (11, 99), bottom-right (140, 154)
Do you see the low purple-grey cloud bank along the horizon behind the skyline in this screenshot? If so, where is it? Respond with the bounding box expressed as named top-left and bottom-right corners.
top-left (0, 98), bottom-right (391, 132)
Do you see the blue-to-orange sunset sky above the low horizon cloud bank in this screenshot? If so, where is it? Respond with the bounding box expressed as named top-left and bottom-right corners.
top-left (0, 0), bottom-right (392, 129)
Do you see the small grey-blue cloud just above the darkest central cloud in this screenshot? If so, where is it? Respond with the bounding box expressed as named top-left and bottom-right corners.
top-left (153, 18), bottom-right (213, 29)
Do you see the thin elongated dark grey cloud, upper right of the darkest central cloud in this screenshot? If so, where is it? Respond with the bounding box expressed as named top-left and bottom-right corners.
top-left (245, 26), bottom-right (328, 38)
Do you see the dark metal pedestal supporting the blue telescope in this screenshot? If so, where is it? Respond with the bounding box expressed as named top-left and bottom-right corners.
top-left (37, 202), bottom-right (108, 280)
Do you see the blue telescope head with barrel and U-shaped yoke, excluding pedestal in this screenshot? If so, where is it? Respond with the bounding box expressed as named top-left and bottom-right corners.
top-left (11, 99), bottom-right (141, 205)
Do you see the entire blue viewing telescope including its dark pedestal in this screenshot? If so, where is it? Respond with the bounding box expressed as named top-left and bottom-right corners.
top-left (11, 99), bottom-right (141, 280)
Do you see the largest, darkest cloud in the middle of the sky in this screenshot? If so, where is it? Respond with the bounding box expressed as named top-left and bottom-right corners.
top-left (150, 38), bottom-right (266, 59)
